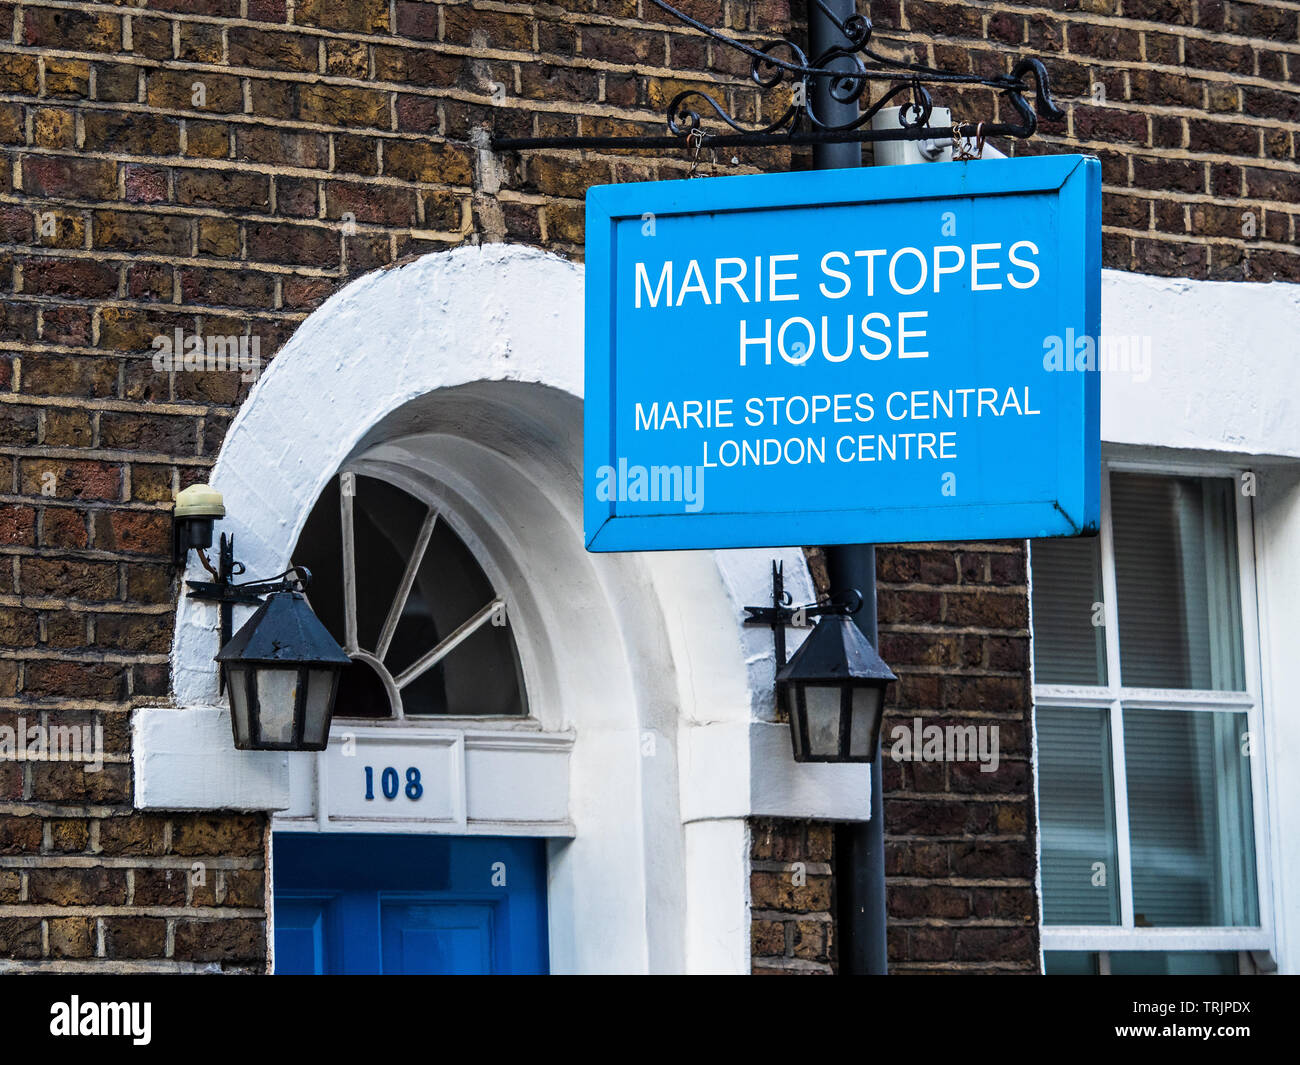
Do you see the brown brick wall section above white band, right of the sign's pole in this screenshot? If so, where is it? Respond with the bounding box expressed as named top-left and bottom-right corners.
top-left (870, 0), bottom-right (1300, 281)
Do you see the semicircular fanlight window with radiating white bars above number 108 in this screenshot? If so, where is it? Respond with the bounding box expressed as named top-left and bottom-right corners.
top-left (293, 472), bottom-right (527, 719)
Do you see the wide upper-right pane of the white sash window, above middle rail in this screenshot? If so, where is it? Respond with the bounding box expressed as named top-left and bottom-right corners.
top-left (1110, 473), bottom-right (1245, 692)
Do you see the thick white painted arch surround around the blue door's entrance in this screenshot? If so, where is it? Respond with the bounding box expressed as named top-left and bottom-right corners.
top-left (134, 244), bottom-right (868, 971)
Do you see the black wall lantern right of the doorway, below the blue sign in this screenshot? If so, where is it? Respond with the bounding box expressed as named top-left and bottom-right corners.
top-left (745, 563), bottom-right (898, 762)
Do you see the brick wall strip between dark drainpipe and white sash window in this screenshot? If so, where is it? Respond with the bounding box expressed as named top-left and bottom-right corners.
top-left (876, 542), bottom-right (1039, 973)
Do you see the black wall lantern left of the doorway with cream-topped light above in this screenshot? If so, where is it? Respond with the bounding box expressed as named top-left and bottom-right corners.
top-left (173, 485), bottom-right (351, 750)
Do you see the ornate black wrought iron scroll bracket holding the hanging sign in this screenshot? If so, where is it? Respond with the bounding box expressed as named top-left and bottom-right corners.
top-left (493, 0), bottom-right (1065, 151)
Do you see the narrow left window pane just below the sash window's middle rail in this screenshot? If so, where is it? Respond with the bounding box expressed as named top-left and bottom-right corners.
top-left (1036, 707), bottom-right (1119, 925)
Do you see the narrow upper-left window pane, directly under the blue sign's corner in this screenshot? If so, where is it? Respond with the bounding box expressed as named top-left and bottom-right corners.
top-left (1031, 536), bottom-right (1106, 684)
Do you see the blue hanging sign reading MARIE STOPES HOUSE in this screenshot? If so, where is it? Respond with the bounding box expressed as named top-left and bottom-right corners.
top-left (584, 156), bottom-right (1101, 551)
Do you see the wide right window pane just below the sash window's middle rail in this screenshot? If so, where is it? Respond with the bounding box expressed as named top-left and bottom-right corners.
top-left (1125, 710), bottom-right (1258, 927)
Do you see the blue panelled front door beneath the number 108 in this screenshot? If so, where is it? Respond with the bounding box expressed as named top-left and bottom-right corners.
top-left (273, 832), bottom-right (547, 975)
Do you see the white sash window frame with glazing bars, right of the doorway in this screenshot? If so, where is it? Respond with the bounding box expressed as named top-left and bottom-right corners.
top-left (1030, 458), bottom-right (1275, 957)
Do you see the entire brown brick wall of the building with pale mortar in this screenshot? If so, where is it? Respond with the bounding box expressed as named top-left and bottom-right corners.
top-left (0, 0), bottom-right (1300, 969)
